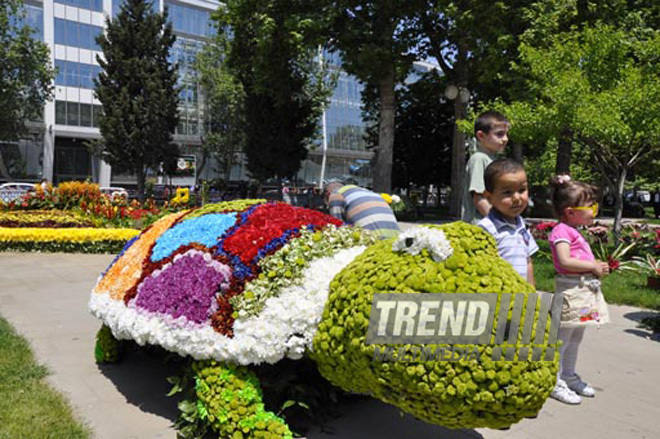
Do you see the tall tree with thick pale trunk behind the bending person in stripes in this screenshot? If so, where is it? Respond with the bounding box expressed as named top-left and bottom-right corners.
top-left (325, 0), bottom-right (423, 192)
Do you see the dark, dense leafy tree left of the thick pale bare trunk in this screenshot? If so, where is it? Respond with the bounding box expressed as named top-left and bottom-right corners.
top-left (215, 0), bottom-right (331, 182)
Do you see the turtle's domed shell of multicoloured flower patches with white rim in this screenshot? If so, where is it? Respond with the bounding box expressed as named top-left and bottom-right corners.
top-left (90, 200), bottom-right (374, 364)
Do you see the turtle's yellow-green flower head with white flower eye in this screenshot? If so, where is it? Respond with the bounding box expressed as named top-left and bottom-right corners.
top-left (311, 223), bottom-right (557, 428)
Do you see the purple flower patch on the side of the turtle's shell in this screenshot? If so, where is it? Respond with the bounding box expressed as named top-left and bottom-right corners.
top-left (134, 250), bottom-right (231, 323)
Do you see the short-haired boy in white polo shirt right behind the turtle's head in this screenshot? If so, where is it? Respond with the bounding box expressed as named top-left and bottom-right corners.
top-left (478, 158), bottom-right (539, 287)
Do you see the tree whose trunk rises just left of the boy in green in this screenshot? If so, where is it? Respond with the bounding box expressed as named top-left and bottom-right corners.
top-left (417, 0), bottom-right (544, 216)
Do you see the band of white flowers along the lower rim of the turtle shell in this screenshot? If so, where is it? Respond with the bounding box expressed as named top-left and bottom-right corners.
top-left (89, 246), bottom-right (366, 365)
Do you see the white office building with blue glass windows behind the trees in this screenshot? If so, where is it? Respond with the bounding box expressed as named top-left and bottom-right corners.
top-left (0, 0), bottom-right (438, 186)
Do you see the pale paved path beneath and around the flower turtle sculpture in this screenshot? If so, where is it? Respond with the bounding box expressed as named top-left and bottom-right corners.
top-left (0, 253), bottom-right (660, 439)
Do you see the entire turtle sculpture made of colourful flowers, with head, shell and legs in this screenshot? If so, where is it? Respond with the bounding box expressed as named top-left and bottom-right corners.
top-left (89, 200), bottom-right (558, 438)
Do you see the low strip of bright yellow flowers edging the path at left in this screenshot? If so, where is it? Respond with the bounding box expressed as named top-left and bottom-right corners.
top-left (0, 227), bottom-right (140, 253)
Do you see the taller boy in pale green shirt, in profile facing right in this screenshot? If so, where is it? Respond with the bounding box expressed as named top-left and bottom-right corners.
top-left (461, 111), bottom-right (509, 224)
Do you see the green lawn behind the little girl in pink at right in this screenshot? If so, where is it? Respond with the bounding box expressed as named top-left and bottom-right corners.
top-left (534, 242), bottom-right (660, 310)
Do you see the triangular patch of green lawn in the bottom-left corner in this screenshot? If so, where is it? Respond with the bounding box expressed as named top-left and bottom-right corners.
top-left (0, 317), bottom-right (91, 439)
